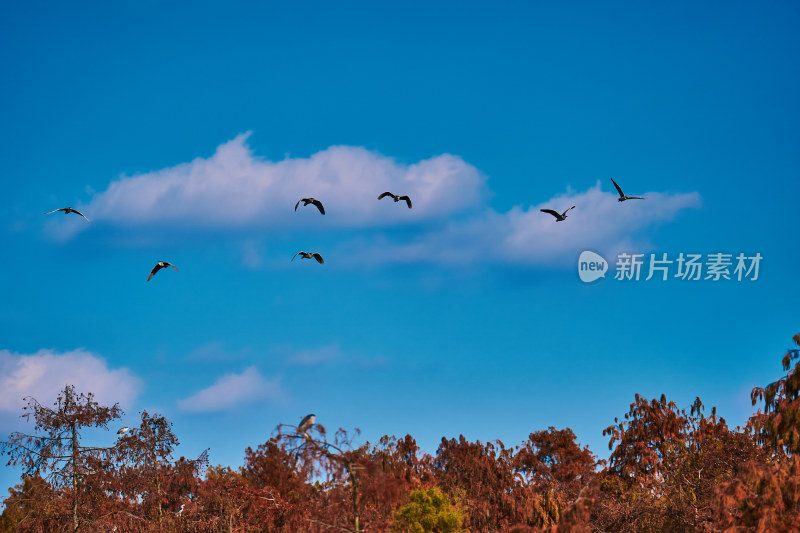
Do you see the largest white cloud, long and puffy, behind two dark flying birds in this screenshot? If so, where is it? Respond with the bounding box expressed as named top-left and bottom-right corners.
top-left (69, 133), bottom-right (485, 232)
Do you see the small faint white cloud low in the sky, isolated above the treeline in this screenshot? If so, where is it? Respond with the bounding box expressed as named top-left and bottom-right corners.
top-left (178, 366), bottom-right (283, 413)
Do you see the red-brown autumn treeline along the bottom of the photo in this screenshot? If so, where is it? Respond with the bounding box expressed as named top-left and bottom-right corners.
top-left (0, 335), bottom-right (800, 533)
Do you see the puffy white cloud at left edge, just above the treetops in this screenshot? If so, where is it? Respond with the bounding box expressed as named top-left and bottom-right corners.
top-left (0, 349), bottom-right (142, 414)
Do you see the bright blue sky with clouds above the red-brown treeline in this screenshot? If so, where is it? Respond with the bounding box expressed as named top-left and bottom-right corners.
top-left (0, 2), bottom-right (800, 485)
